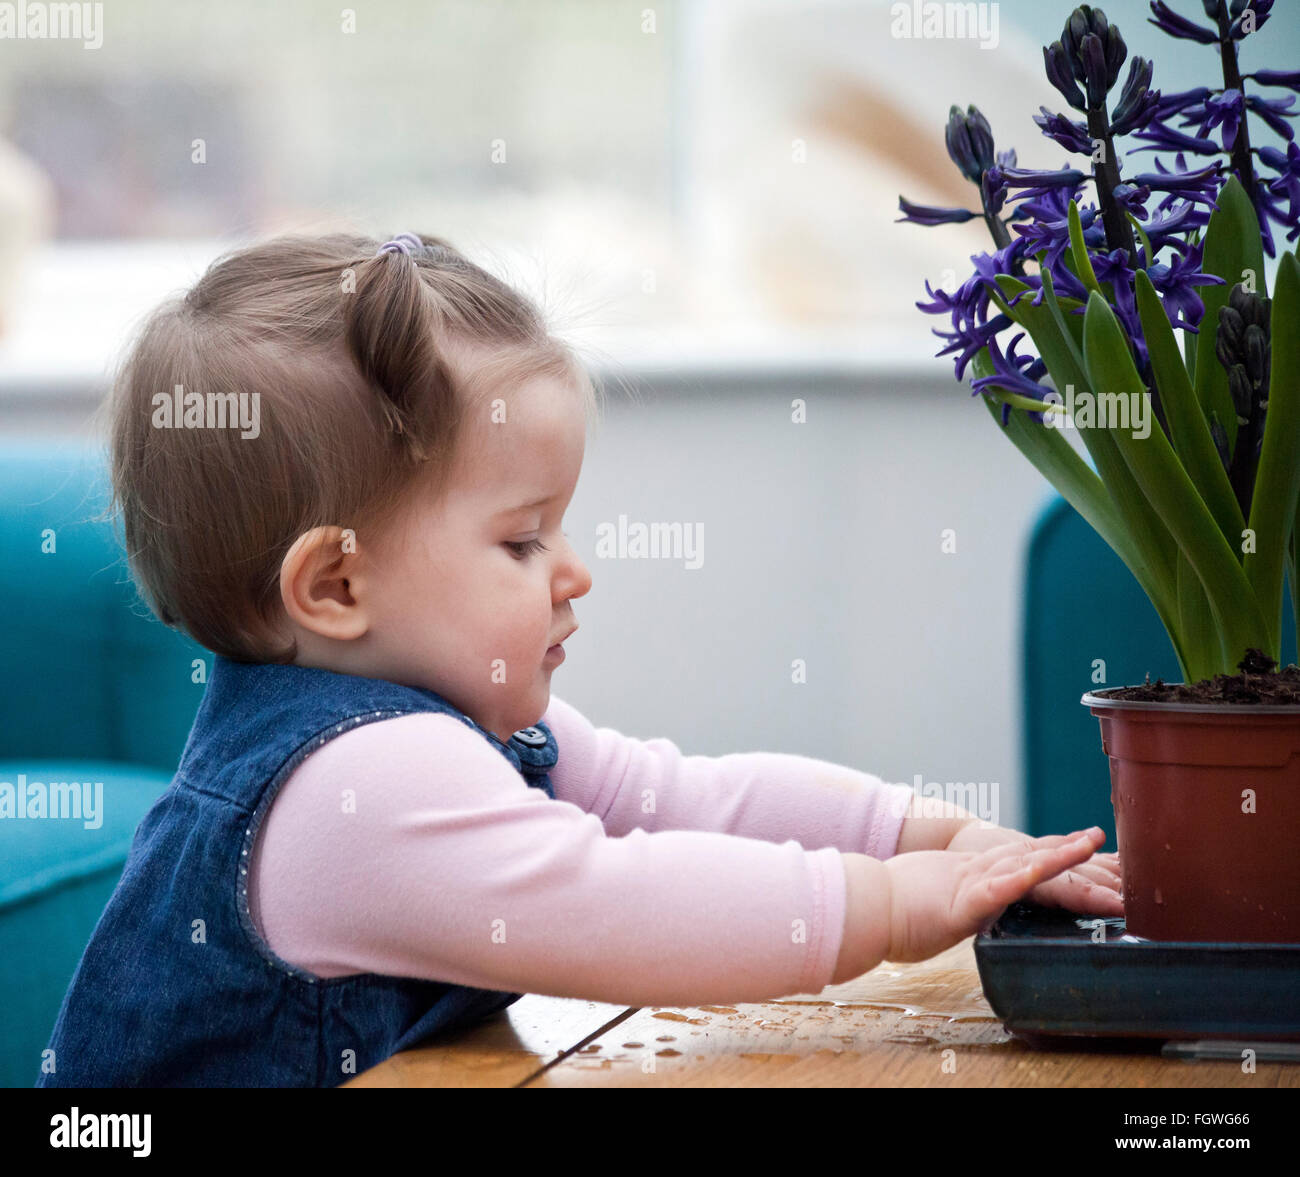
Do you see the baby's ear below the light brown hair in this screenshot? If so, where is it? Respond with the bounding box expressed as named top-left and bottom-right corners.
top-left (280, 527), bottom-right (371, 641)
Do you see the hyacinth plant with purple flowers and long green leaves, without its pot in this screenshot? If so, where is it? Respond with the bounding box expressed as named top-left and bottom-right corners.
top-left (900, 0), bottom-right (1300, 683)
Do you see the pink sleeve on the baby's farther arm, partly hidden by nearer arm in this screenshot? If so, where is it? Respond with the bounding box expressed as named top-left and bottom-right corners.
top-left (542, 694), bottom-right (913, 858)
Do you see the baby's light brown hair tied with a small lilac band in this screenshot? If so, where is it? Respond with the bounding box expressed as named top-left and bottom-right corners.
top-left (108, 233), bottom-right (595, 662)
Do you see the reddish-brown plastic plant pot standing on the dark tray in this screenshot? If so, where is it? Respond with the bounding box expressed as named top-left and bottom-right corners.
top-left (1080, 691), bottom-right (1300, 944)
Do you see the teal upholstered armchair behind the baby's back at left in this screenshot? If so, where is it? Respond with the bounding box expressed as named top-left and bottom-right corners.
top-left (0, 441), bottom-right (212, 1086)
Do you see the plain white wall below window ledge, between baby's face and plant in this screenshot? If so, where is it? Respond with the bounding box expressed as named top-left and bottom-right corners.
top-left (553, 360), bottom-right (1050, 825)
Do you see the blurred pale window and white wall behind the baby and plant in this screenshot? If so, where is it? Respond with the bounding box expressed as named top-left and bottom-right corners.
top-left (0, 0), bottom-right (1300, 825)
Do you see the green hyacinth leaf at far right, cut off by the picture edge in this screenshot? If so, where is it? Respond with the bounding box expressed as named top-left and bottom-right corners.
top-left (1245, 254), bottom-right (1300, 661)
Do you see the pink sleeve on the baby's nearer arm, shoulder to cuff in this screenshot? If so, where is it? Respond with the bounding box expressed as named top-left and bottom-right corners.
top-left (248, 714), bottom-right (845, 1005)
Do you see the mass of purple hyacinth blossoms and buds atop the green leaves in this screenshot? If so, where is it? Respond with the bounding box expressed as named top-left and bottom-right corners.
top-left (898, 0), bottom-right (1300, 428)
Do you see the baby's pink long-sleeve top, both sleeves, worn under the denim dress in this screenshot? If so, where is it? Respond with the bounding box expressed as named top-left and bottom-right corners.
top-left (248, 694), bottom-right (913, 1005)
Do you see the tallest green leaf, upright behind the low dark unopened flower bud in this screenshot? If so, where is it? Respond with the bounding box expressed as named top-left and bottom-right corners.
top-left (1195, 176), bottom-right (1266, 453)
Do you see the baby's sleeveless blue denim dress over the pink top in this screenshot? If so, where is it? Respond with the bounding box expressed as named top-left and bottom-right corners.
top-left (36, 657), bottom-right (556, 1087)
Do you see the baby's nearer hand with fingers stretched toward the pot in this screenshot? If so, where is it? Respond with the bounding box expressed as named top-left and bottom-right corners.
top-left (884, 826), bottom-right (1106, 961)
